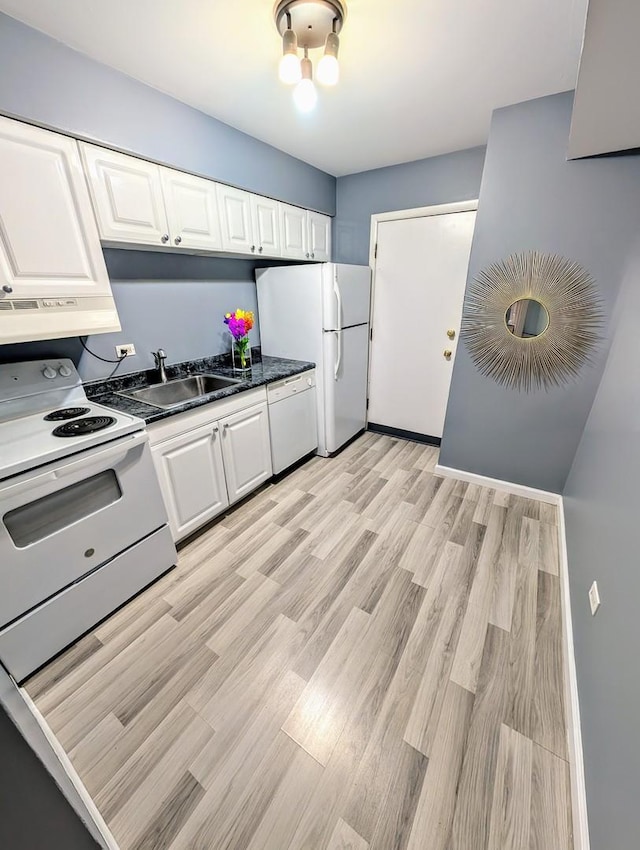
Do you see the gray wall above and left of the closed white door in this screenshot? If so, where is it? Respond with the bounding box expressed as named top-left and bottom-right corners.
top-left (333, 147), bottom-right (485, 265)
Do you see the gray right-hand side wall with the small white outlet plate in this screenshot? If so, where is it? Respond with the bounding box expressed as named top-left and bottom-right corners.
top-left (564, 262), bottom-right (640, 850)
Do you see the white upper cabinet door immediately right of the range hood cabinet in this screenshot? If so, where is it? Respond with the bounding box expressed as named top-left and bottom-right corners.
top-left (80, 142), bottom-right (169, 245)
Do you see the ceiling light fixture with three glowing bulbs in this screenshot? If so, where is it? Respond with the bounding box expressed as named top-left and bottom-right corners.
top-left (274, 0), bottom-right (347, 112)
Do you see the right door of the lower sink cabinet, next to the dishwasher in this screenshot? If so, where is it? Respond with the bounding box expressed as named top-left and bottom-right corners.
top-left (220, 404), bottom-right (271, 504)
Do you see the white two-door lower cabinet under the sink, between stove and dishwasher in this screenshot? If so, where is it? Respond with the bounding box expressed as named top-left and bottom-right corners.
top-left (148, 387), bottom-right (272, 541)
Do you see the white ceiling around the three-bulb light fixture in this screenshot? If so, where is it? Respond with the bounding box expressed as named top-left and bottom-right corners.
top-left (0, 0), bottom-right (588, 175)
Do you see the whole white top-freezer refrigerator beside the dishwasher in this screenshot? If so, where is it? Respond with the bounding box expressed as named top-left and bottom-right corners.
top-left (256, 263), bottom-right (371, 457)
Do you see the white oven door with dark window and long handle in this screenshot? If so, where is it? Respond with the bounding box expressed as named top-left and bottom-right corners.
top-left (0, 431), bottom-right (167, 626)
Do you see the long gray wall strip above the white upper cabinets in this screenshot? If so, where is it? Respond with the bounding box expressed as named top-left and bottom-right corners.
top-left (0, 11), bottom-right (335, 215)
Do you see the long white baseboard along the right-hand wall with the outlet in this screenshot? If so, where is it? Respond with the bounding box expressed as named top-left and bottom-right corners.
top-left (558, 499), bottom-right (590, 850)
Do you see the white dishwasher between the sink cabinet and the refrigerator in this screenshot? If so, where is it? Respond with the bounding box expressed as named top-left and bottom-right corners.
top-left (267, 370), bottom-right (318, 474)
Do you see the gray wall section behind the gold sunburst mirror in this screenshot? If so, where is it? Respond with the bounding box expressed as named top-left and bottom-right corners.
top-left (440, 93), bottom-right (640, 493)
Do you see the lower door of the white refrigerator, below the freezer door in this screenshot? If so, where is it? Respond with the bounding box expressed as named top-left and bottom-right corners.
top-left (318, 325), bottom-right (369, 455)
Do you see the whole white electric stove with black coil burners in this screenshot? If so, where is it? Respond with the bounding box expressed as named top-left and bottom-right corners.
top-left (0, 360), bottom-right (176, 681)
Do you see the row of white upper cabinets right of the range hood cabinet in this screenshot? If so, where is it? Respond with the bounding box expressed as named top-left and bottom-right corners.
top-left (80, 142), bottom-right (331, 260)
